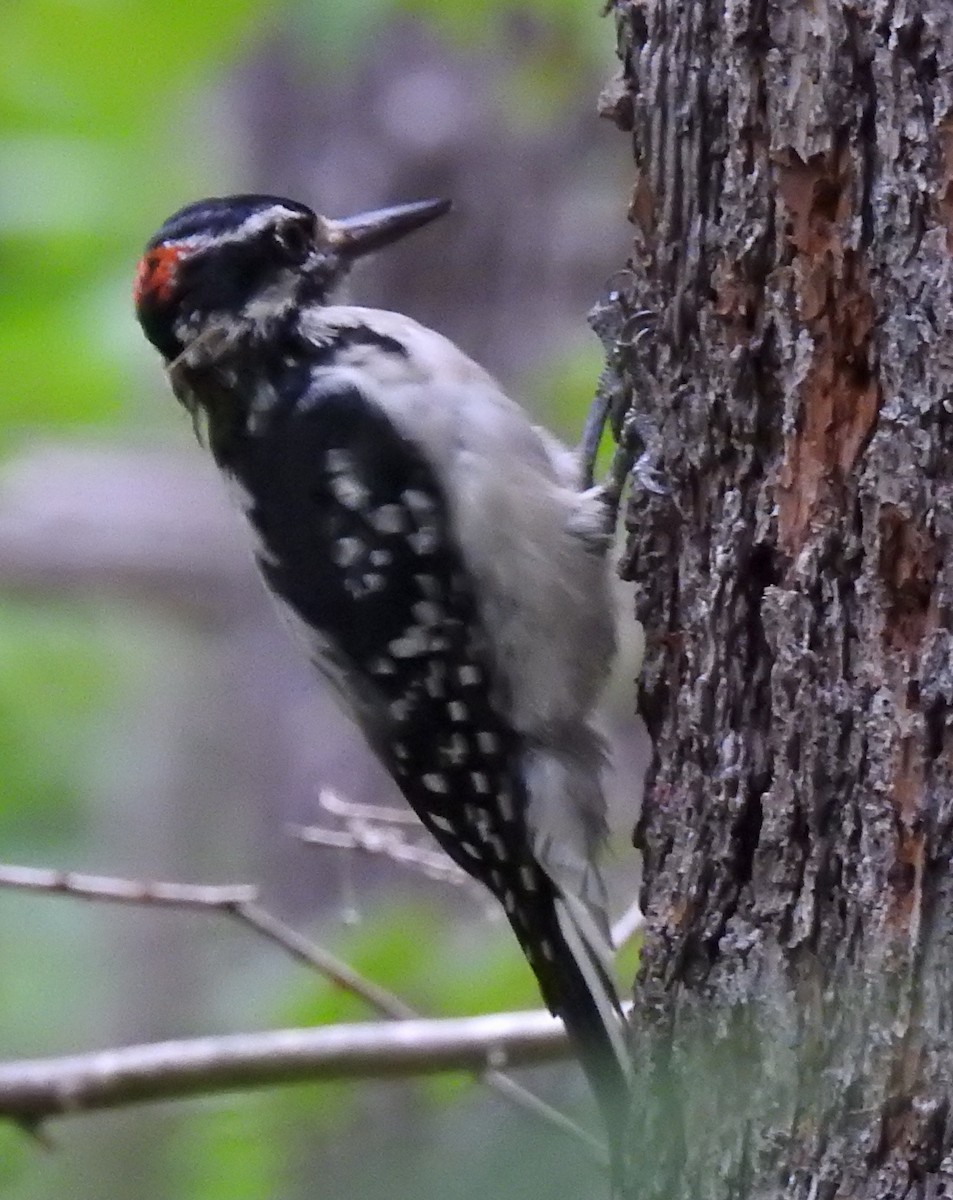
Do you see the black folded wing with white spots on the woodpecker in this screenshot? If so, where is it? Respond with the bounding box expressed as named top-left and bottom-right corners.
top-left (224, 389), bottom-right (531, 873)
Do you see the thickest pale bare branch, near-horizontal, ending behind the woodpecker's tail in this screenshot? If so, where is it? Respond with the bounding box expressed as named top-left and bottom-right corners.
top-left (0, 1012), bottom-right (568, 1127)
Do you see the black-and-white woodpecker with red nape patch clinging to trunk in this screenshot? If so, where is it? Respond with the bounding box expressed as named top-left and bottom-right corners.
top-left (134, 196), bottom-right (630, 1192)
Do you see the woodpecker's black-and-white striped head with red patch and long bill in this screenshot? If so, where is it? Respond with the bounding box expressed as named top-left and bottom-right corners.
top-left (133, 196), bottom-right (450, 361)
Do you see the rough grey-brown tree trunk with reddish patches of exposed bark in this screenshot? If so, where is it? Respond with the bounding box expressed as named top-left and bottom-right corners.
top-left (605, 0), bottom-right (953, 1200)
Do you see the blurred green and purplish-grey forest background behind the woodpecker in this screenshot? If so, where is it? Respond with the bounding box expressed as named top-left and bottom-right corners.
top-left (0, 0), bottom-right (639, 1200)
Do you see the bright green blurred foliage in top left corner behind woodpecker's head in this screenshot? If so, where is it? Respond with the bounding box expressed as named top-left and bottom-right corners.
top-left (0, 0), bottom-right (268, 450)
